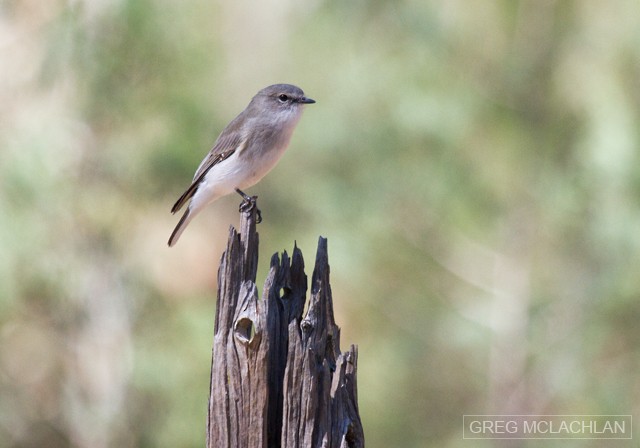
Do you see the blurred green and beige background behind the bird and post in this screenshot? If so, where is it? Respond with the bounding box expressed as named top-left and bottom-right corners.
top-left (0, 0), bottom-right (640, 448)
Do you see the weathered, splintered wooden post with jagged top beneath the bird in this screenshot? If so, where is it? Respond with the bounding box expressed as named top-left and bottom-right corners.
top-left (207, 207), bottom-right (364, 448)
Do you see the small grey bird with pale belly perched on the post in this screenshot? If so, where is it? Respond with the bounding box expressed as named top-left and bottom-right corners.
top-left (169, 84), bottom-right (315, 247)
